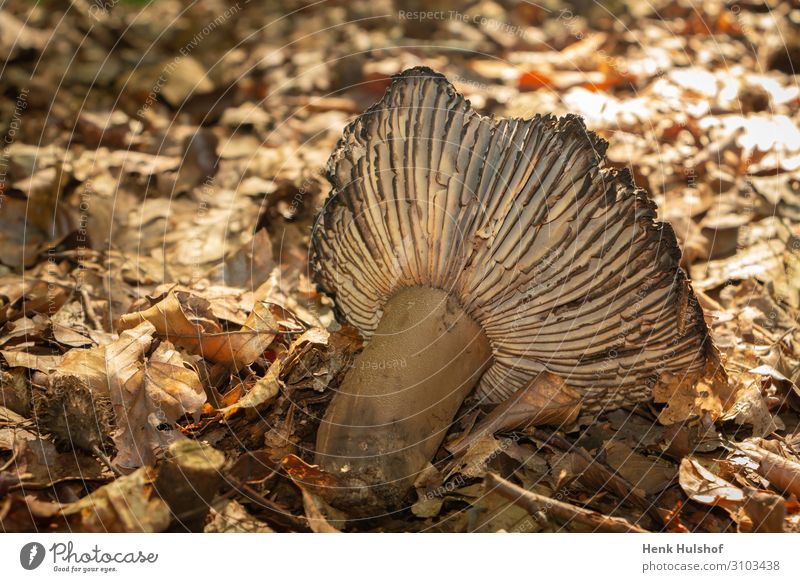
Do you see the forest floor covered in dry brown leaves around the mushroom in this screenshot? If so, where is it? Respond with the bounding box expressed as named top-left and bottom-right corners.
top-left (0, 0), bottom-right (800, 532)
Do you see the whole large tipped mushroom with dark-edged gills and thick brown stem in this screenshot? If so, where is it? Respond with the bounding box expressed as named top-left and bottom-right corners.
top-left (311, 67), bottom-right (709, 508)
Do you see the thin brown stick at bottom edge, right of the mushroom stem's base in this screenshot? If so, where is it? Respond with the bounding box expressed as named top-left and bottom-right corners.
top-left (485, 473), bottom-right (647, 533)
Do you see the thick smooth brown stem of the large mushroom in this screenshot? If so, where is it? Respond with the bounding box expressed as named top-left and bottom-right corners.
top-left (316, 287), bottom-right (492, 508)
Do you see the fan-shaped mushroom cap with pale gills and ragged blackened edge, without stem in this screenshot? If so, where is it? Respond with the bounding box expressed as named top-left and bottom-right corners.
top-left (312, 67), bottom-right (710, 411)
